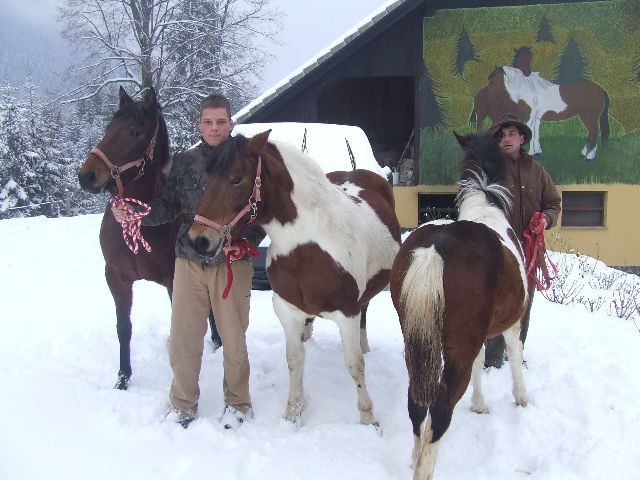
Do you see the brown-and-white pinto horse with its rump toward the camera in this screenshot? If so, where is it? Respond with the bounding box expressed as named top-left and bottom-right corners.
top-left (391, 129), bottom-right (528, 480)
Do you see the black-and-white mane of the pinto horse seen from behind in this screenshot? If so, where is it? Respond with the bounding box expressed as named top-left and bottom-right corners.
top-left (456, 132), bottom-right (511, 214)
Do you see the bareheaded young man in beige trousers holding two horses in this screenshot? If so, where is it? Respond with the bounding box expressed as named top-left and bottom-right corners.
top-left (112, 94), bottom-right (265, 429)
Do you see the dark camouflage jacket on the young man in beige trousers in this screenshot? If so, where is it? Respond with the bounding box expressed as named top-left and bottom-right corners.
top-left (142, 142), bottom-right (266, 266)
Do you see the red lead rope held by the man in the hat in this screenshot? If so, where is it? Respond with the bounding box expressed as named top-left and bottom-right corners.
top-left (523, 212), bottom-right (558, 291)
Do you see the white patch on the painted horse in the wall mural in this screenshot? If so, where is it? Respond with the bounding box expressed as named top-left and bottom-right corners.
top-left (502, 65), bottom-right (568, 155)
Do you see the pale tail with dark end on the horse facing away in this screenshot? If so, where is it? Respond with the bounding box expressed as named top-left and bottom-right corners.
top-left (400, 246), bottom-right (445, 407)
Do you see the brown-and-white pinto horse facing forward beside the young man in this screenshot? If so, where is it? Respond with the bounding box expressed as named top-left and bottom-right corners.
top-left (189, 131), bottom-right (400, 424)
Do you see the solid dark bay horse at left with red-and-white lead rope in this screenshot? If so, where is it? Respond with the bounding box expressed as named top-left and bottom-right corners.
top-left (78, 87), bottom-right (220, 390)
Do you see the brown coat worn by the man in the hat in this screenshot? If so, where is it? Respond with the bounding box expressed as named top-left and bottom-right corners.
top-left (505, 153), bottom-right (561, 241)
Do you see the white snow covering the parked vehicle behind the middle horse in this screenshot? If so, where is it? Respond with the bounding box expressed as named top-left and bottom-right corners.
top-left (232, 122), bottom-right (390, 178)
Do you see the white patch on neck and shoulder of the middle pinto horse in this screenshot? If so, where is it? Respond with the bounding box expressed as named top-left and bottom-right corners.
top-left (264, 141), bottom-right (400, 294)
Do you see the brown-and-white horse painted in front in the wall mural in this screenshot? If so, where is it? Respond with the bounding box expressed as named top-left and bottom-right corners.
top-left (478, 65), bottom-right (610, 162)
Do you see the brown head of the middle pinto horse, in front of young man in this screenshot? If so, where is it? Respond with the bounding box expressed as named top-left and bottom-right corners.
top-left (188, 130), bottom-right (274, 255)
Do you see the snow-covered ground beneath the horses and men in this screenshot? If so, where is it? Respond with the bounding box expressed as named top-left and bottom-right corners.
top-left (0, 215), bottom-right (640, 480)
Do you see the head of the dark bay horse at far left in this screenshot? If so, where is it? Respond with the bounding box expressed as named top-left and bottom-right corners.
top-left (78, 87), bottom-right (169, 196)
